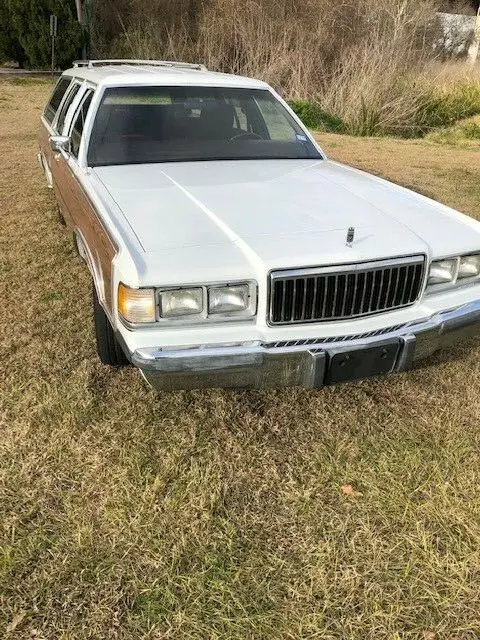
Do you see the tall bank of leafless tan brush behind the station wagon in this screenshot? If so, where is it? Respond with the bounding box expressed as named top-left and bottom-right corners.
top-left (92, 0), bottom-right (464, 133)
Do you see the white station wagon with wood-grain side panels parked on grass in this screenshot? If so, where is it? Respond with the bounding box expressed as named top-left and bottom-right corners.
top-left (39, 60), bottom-right (480, 390)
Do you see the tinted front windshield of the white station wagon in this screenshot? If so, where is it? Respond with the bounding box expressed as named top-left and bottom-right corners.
top-left (88, 86), bottom-right (321, 166)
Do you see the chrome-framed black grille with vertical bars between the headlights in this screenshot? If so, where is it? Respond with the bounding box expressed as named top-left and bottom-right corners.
top-left (269, 256), bottom-right (425, 324)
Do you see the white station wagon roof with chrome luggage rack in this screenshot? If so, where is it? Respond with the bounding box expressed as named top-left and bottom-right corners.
top-left (63, 60), bottom-right (268, 89)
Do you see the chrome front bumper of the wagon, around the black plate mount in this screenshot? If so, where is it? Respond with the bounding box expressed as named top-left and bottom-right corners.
top-left (130, 300), bottom-right (480, 391)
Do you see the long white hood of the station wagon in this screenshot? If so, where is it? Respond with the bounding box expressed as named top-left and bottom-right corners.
top-left (93, 160), bottom-right (480, 269)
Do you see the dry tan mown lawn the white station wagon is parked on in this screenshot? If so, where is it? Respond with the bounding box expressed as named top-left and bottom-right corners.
top-left (0, 82), bottom-right (480, 640)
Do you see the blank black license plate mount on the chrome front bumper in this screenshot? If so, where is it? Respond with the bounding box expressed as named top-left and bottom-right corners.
top-left (325, 339), bottom-right (400, 384)
